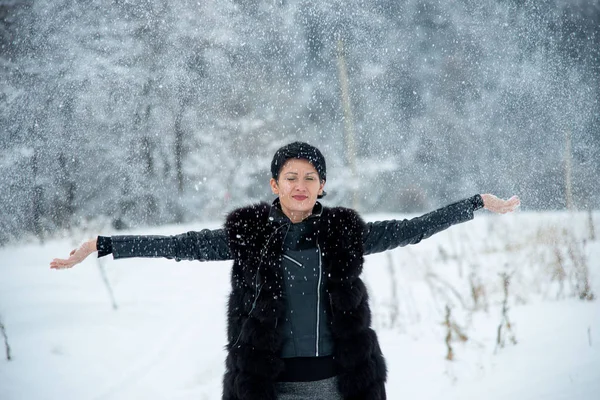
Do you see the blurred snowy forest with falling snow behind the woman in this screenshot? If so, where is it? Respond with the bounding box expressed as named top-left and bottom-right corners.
top-left (0, 0), bottom-right (600, 245)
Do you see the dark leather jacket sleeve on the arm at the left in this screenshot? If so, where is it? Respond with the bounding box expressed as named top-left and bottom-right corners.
top-left (98, 229), bottom-right (232, 261)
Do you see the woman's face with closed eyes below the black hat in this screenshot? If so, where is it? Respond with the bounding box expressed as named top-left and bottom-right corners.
top-left (271, 158), bottom-right (325, 223)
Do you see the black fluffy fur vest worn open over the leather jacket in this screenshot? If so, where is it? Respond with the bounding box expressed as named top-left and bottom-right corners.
top-left (223, 203), bottom-right (387, 400)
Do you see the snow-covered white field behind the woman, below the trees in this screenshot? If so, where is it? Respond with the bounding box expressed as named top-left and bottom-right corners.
top-left (0, 211), bottom-right (600, 400)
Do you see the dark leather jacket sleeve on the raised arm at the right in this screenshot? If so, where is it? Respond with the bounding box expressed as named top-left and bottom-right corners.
top-left (363, 195), bottom-right (483, 255)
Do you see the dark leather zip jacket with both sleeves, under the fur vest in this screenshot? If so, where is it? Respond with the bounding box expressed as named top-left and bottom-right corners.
top-left (98, 195), bottom-right (483, 378)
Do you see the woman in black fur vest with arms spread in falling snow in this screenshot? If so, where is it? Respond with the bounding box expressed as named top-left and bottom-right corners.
top-left (50, 142), bottom-right (519, 400)
